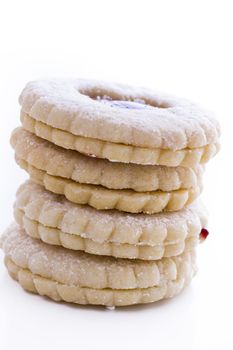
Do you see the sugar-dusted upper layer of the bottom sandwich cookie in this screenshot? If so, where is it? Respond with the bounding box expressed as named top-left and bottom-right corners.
top-left (2, 224), bottom-right (194, 289)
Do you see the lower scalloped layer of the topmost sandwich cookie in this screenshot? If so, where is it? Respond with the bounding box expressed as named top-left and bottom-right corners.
top-left (20, 111), bottom-right (220, 167)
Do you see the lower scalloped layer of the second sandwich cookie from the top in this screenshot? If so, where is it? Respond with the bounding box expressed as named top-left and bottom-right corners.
top-left (16, 156), bottom-right (201, 214)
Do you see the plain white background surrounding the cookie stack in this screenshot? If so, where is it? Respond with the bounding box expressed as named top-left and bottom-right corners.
top-left (0, 0), bottom-right (233, 350)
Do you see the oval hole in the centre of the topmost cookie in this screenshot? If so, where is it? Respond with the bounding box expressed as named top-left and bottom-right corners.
top-left (80, 89), bottom-right (170, 109)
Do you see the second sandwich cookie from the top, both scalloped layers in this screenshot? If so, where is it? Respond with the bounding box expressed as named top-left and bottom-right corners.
top-left (11, 129), bottom-right (202, 214)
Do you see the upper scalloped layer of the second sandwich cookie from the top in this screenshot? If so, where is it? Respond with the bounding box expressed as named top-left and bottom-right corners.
top-left (11, 128), bottom-right (203, 192)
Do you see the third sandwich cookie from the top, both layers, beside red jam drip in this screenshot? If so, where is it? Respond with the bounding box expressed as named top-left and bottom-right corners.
top-left (14, 182), bottom-right (207, 260)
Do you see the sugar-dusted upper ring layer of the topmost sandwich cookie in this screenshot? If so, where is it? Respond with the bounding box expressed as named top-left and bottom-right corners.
top-left (20, 80), bottom-right (219, 150)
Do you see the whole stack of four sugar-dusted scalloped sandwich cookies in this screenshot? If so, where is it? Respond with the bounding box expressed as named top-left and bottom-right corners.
top-left (2, 80), bottom-right (220, 306)
